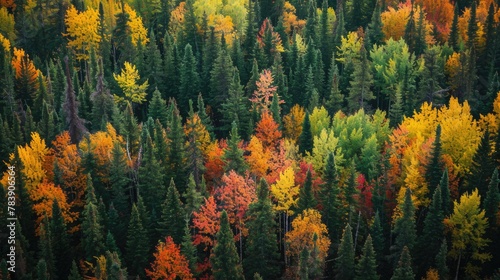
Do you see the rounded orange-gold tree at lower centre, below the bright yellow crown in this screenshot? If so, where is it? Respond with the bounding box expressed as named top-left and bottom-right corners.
top-left (286, 209), bottom-right (331, 262)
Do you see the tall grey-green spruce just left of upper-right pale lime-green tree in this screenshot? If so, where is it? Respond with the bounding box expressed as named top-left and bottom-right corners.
top-left (347, 47), bottom-right (375, 113)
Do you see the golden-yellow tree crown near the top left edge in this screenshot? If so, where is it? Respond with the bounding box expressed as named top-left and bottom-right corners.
top-left (64, 5), bottom-right (102, 60)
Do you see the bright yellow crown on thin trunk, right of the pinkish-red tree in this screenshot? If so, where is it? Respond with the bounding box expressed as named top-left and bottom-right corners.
top-left (271, 167), bottom-right (299, 215)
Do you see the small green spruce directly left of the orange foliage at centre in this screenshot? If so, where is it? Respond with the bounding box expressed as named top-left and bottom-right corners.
top-left (223, 122), bottom-right (247, 174)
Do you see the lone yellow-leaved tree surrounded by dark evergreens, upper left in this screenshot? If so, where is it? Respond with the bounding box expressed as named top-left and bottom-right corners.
top-left (113, 61), bottom-right (149, 104)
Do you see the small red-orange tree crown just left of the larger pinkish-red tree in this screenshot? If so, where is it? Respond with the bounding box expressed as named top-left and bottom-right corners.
top-left (193, 196), bottom-right (220, 248)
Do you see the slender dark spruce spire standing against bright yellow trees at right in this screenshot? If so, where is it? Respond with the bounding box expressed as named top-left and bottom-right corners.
top-left (425, 124), bottom-right (444, 201)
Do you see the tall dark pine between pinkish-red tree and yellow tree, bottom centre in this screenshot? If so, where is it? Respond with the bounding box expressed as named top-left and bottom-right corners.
top-left (243, 178), bottom-right (279, 279)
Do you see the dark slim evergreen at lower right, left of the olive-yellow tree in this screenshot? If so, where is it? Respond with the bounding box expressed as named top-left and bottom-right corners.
top-left (391, 188), bottom-right (417, 264)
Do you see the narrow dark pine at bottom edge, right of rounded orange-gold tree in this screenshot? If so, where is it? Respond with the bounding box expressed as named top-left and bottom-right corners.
top-left (335, 224), bottom-right (355, 280)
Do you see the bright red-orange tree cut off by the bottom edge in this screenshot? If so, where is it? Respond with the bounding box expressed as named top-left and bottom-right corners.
top-left (146, 236), bottom-right (194, 280)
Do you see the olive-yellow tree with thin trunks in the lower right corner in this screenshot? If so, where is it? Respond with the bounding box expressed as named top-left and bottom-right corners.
top-left (445, 189), bottom-right (491, 278)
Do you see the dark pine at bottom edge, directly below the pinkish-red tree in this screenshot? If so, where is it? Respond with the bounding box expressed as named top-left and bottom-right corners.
top-left (210, 210), bottom-right (245, 280)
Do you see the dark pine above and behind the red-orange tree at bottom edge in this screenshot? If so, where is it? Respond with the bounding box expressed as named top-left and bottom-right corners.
top-left (158, 179), bottom-right (186, 244)
